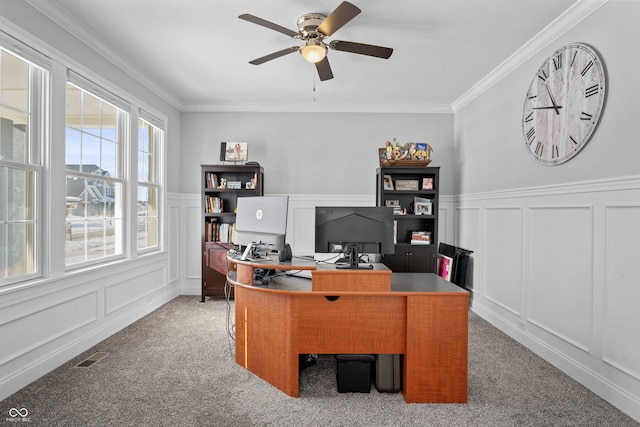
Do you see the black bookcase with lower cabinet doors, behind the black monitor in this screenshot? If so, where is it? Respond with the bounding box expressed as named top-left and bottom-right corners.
top-left (376, 166), bottom-right (440, 273)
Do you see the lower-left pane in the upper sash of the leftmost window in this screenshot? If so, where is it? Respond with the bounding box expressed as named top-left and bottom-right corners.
top-left (0, 106), bottom-right (29, 163)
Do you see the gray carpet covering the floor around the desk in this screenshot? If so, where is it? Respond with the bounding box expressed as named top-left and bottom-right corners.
top-left (0, 296), bottom-right (639, 426)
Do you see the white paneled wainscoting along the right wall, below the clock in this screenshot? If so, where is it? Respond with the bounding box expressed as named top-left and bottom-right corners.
top-left (455, 176), bottom-right (640, 419)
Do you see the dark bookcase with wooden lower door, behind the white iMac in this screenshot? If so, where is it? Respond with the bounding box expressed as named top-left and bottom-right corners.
top-left (200, 165), bottom-right (264, 302)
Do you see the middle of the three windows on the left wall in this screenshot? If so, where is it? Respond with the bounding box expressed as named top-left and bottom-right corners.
top-left (65, 82), bottom-right (129, 266)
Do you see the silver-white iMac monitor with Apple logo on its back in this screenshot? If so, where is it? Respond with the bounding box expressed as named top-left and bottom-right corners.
top-left (233, 196), bottom-right (289, 259)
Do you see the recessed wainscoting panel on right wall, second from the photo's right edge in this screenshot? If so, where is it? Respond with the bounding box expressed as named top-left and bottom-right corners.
top-left (526, 206), bottom-right (593, 351)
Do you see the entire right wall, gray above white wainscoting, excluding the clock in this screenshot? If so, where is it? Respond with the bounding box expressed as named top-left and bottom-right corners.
top-left (455, 1), bottom-right (640, 419)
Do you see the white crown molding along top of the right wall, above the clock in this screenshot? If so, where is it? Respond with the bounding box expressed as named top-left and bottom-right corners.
top-left (451, 0), bottom-right (609, 113)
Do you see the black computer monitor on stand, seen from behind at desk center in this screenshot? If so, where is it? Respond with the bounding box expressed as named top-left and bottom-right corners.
top-left (315, 206), bottom-right (395, 268)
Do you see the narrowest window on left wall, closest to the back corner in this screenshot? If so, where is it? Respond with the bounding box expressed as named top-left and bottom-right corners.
top-left (137, 118), bottom-right (164, 250)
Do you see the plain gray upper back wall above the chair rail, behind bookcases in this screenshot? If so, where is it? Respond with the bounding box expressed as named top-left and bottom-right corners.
top-left (182, 113), bottom-right (453, 196)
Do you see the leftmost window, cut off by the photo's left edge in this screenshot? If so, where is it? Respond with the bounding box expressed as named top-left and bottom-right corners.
top-left (0, 48), bottom-right (49, 284)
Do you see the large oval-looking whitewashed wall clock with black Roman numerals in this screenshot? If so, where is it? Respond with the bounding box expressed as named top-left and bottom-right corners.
top-left (522, 43), bottom-right (606, 165)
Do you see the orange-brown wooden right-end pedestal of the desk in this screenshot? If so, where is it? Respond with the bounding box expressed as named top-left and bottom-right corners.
top-left (402, 294), bottom-right (468, 403)
